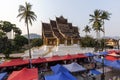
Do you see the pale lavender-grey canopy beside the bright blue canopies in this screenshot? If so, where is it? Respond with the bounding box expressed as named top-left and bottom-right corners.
top-left (63, 62), bottom-right (86, 72)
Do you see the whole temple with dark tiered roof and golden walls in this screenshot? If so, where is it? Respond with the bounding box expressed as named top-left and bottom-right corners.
top-left (42, 16), bottom-right (80, 45)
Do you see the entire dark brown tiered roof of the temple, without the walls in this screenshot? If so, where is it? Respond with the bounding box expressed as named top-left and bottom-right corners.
top-left (42, 16), bottom-right (80, 39)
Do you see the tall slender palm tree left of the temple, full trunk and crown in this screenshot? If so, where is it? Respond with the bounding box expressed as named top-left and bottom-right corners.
top-left (17, 2), bottom-right (37, 67)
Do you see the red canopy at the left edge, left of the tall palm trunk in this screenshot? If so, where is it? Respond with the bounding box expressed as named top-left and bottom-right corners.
top-left (0, 59), bottom-right (29, 67)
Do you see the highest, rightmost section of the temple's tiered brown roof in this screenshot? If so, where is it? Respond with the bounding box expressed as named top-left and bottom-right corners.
top-left (56, 16), bottom-right (80, 38)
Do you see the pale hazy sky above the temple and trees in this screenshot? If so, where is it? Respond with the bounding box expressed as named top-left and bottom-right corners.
top-left (0, 0), bottom-right (120, 36)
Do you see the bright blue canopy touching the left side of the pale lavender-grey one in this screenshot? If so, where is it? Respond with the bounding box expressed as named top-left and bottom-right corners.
top-left (51, 64), bottom-right (69, 73)
